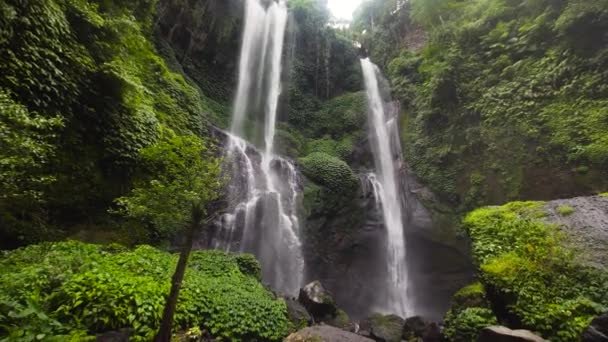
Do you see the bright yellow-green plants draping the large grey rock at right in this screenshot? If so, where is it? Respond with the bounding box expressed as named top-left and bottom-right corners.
top-left (464, 202), bottom-right (608, 341)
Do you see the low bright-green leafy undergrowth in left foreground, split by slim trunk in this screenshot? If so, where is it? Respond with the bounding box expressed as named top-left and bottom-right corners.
top-left (0, 242), bottom-right (290, 341)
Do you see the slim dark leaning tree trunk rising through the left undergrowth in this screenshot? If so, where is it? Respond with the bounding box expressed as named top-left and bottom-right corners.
top-left (154, 206), bottom-right (203, 342)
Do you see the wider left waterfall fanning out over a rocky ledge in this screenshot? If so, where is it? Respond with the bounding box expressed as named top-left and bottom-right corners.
top-left (213, 0), bottom-right (304, 295)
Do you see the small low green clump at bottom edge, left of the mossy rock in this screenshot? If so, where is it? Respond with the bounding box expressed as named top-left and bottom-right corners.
top-left (443, 307), bottom-right (498, 342)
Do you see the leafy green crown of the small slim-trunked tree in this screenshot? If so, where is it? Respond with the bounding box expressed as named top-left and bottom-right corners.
top-left (116, 131), bottom-right (220, 238)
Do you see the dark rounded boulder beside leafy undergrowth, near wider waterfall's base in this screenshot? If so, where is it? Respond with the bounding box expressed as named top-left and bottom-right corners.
top-left (298, 280), bottom-right (338, 322)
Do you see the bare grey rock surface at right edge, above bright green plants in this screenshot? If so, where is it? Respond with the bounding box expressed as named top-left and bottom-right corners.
top-left (545, 196), bottom-right (608, 271)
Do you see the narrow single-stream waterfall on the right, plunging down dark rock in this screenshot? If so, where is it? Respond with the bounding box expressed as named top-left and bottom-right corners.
top-left (361, 58), bottom-right (409, 316)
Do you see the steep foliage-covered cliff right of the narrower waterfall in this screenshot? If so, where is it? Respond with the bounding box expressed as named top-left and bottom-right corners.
top-left (355, 0), bottom-right (608, 210)
